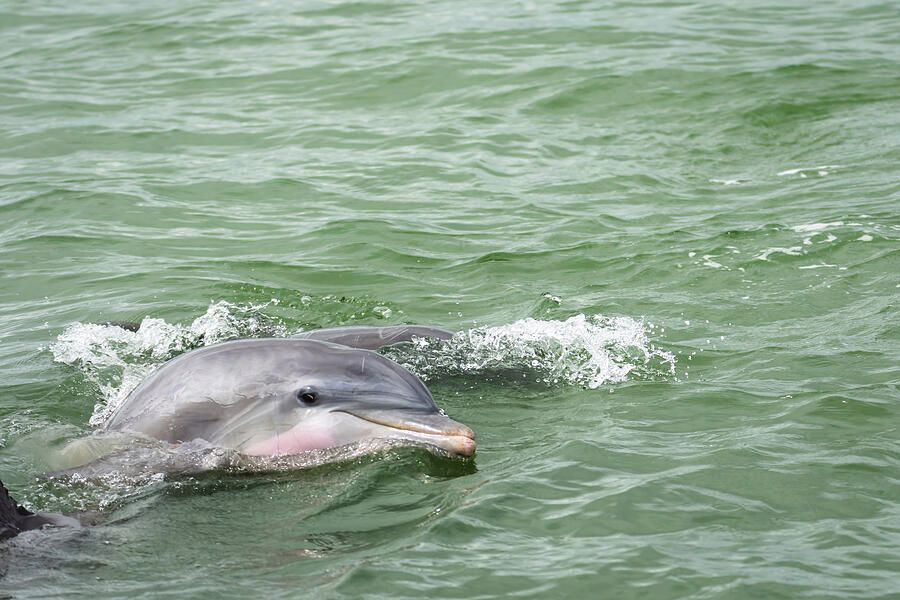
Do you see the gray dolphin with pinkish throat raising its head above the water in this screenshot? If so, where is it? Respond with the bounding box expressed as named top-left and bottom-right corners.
top-left (104, 326), bottom-right (475, 457)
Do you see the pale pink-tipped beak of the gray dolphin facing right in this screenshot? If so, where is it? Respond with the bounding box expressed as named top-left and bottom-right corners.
top-left (341, 409), bottom-right (475, 456)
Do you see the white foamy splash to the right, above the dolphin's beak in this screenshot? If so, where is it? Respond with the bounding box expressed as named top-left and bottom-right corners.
top-left (386, 314), bottom-right (675, 389)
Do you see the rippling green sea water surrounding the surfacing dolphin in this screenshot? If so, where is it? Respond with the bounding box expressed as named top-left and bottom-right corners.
top-left (0, 0), bottom-right (900, 599)
